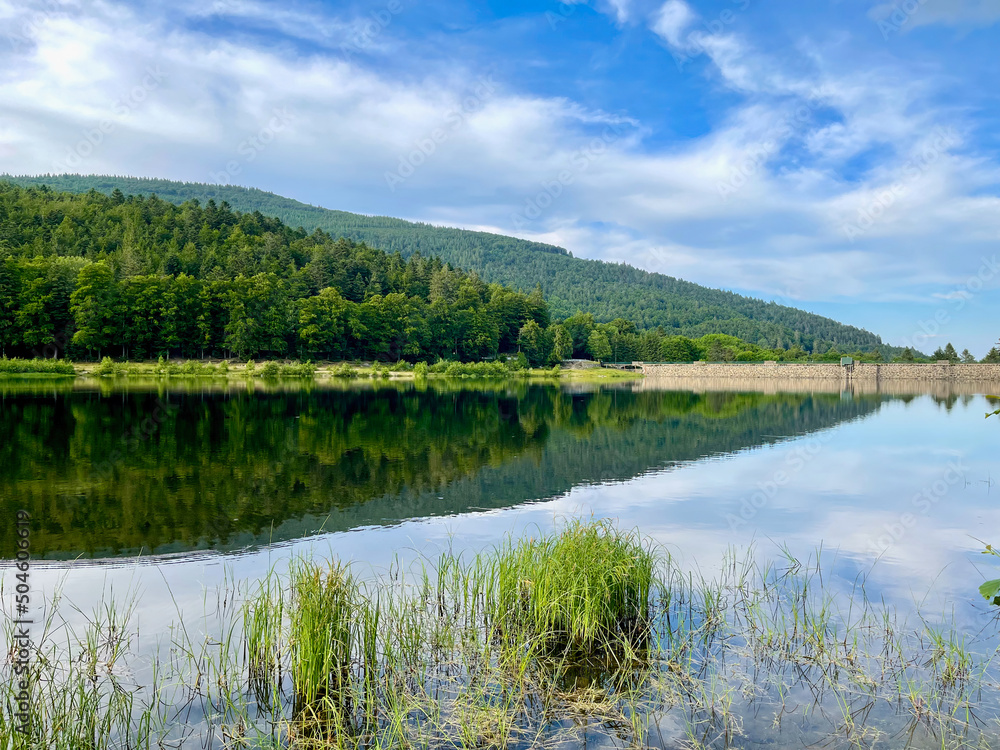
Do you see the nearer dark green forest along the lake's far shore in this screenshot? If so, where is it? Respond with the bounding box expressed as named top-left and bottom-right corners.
top-left (0, 183), bottom-right (920, 367)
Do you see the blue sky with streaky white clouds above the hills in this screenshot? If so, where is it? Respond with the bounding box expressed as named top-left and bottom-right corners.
top-left (0, 0), bottom-right (1000, 357)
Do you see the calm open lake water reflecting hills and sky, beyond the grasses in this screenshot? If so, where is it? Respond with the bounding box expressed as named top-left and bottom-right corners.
top-left (0, 379), bottom-right (1000, 747)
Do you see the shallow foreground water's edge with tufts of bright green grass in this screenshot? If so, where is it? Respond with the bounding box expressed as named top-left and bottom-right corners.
top-left (0, 523), bottom-right (1000, 750)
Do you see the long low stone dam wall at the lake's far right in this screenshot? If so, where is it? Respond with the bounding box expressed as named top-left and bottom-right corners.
top-left (633, 362), bottom-right (1000, 386)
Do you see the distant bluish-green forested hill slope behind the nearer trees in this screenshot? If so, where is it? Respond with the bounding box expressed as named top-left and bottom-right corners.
top-left (0, 175), bottom-right (902, 356)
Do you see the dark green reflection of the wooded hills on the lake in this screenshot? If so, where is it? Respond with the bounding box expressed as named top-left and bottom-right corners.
top-left (0, 381), bottom-right (884, 559)
